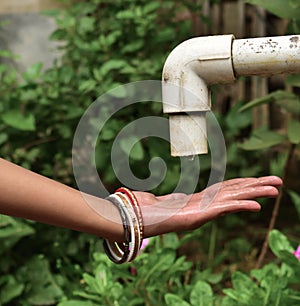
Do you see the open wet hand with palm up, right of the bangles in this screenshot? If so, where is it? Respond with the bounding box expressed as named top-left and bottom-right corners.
top-left (134, 176), bottom-right (282, 237)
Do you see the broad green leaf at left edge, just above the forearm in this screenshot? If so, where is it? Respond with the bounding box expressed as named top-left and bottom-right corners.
top-left (1, 110), bottom-right (35, 131)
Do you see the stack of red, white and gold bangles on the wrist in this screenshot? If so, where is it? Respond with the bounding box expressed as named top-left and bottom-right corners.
top-left (103, 187), bottom-right (144, 264)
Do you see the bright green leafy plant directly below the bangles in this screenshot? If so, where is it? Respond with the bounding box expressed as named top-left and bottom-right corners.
top-left (59, 234), bottom-right (192, 306)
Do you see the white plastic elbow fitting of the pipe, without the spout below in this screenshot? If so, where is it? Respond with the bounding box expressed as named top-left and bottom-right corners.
top-left (162, 35), bottom-right (235, 113)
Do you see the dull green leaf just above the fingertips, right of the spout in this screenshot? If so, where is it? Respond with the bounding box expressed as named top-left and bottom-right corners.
top-left (238, 129), bottom-right (287, 150)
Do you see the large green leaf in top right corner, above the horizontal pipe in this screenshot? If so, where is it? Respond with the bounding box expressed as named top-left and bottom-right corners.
top-left (246, 0), bottom-right (300, 19)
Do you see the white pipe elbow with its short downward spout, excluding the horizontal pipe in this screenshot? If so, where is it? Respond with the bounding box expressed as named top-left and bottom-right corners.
top-left (162, 35), bottom-right (235, 156)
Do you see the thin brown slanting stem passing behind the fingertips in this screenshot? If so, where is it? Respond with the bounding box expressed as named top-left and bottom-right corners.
top-left (255, 144), bottom-right (296, 269)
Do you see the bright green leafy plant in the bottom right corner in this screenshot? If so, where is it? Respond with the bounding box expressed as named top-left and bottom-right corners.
top-left (221, 230), bottom-right (300, 305)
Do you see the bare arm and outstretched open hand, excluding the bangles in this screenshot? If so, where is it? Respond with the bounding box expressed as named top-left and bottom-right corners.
top-left (0, 159), bottom-right (282, 241)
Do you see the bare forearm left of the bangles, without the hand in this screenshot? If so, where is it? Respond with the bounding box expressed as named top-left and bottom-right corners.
top-left (0, 158), bottom-right (123, 240)
